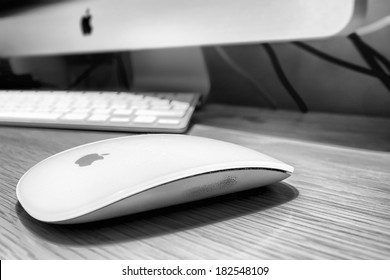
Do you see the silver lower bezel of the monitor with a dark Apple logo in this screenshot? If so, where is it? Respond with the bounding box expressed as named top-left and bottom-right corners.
top-left (0, 0), bottom-right (368, 57)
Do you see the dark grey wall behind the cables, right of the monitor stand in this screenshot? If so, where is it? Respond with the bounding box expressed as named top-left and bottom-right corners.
top-left (204, 29), bottom-right (390, 117)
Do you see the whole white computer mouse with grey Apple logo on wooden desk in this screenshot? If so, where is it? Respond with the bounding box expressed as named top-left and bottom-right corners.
top-left (16, 134), bottom-right (294, 224)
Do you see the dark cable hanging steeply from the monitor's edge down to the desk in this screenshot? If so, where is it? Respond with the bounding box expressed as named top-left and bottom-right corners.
top-left (263, 44), bottom-right (308, 113)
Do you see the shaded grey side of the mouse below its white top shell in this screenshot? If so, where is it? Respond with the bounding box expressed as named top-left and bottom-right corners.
top-left (62, 168), bottom-right (292, 224)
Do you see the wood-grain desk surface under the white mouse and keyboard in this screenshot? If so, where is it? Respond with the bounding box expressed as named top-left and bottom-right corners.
top-left (0, 105), bottom-right (390, 259)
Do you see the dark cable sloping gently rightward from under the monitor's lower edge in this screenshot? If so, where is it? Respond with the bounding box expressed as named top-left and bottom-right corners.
top-left (292, 42), bottom-right (377, 77)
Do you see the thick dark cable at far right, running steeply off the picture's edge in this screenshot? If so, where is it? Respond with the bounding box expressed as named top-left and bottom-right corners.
top-left (348, 33), bottom-right (390, 92)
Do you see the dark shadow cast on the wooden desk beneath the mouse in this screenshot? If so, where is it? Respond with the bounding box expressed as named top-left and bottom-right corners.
top-left (16, 182), bottom-right (299, 246)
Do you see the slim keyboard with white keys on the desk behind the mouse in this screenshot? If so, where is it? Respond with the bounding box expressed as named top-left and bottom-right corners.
top-left (0, 90), bottom-right (200, 133)
